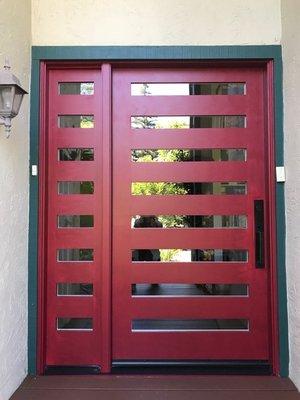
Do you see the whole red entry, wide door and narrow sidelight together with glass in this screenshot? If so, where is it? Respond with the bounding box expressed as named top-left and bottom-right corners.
top-left (41, 64), bottom-right (271, 372)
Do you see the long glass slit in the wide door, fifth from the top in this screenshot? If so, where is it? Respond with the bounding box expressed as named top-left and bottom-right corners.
top-left (131, 215), bottom-right (247, 229)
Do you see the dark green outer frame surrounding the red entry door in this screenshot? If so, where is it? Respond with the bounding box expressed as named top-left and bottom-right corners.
top-left (28, 45), bottom-right (289, 377)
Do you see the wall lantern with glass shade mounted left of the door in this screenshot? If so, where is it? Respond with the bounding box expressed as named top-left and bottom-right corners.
top-left (0, 61), bottom-right (28, 138)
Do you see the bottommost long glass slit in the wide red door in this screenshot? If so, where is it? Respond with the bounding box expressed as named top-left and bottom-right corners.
top-left (131, 319), bottom-right (249, 332)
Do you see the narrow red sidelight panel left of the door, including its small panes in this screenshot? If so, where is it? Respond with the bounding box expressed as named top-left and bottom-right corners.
top-left (45, 67), bottom-right (106, 366)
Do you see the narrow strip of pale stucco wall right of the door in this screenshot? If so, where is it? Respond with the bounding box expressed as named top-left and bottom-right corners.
top-left (282, 0), bottom-right (300, 389)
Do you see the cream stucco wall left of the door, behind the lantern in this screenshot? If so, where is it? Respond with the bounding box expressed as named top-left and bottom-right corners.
top-left (0, 0), bottom-right (30, 400)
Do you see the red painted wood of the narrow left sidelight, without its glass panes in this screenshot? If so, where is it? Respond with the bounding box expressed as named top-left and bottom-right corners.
top-left (44, 67), bottom-right (105, 369)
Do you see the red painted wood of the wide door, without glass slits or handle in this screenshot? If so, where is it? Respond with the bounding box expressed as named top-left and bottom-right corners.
top-left (112, 68), bottom-right (270, 360)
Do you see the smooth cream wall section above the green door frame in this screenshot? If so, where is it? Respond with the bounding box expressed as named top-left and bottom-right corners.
top-left (32, 0), bottom-right (281, 46)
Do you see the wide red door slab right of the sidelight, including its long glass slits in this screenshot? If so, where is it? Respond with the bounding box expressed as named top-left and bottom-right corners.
top-left (112, 67), bottom-right (270, 361)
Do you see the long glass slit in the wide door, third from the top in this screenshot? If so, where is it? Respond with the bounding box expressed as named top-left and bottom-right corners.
top-left (131, 149), bottom-right (247, 163)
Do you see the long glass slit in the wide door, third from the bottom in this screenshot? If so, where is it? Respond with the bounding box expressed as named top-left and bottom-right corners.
top-left (132, 249), bottom-right (248, 263)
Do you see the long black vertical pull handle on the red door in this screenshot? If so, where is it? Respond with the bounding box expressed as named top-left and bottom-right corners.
top-left (254, 200), bottom-right (265, 268)
